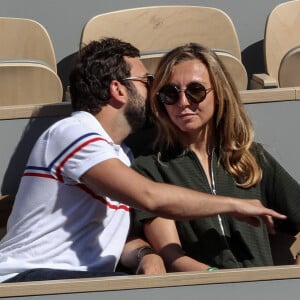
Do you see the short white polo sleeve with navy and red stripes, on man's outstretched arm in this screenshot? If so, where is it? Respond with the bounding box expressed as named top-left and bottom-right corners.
top-left (46, 121), bottom-right (118, 184)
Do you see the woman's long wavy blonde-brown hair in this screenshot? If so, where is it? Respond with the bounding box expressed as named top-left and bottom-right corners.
top-left (150, 43), bottom-right (262, 188)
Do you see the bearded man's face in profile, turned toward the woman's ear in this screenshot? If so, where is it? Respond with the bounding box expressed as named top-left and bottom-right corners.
top-left (125, 57), bottom-right (148, 132)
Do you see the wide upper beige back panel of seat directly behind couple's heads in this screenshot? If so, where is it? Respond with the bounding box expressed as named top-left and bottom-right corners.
top-left (81, 5), bottom-right (241, 60)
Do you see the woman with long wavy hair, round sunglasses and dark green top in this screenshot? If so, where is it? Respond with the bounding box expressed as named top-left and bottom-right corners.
top-left (133, 43), bottom-right (300, 271)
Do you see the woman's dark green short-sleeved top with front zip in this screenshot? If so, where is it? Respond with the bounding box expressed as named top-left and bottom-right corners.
top-left (132, 145), bottom-right (300, 268)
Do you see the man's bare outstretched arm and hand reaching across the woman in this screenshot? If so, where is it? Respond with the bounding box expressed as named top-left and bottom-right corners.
top-left (81, 159), bottom-right (285, 226)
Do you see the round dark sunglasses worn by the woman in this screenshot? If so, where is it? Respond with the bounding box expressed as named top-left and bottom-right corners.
top-left (156, 82), bottom-right (213, 105)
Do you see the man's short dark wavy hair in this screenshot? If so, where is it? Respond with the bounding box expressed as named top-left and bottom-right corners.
top-left (69, 38), bottom-right (140, 115)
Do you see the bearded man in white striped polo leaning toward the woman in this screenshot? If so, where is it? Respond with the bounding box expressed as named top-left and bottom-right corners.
top-left (0, 38), bottom-right (284, 282)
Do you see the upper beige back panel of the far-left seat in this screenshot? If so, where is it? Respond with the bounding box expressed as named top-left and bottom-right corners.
top-left (0, 17), bottom-right (57, 72)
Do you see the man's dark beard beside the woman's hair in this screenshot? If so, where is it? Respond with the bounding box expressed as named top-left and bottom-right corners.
top-left (125, 87), bottom-right (146, 132)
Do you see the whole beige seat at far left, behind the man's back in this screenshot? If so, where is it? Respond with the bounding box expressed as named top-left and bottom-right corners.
top-left (0, 17), bottom-right (63, 106)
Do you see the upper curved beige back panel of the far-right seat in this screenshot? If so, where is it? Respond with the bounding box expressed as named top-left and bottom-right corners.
top-left (264, 0), bottom-right (300, 87)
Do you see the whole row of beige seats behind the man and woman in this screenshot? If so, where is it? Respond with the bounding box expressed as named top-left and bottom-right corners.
top-left (0, 0), bottom-right (300, 106)
